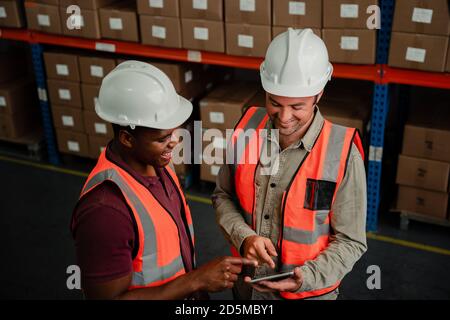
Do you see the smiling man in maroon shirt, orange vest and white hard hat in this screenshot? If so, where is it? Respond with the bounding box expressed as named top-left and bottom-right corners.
top-left (71, 61), bottom-right (256, 300)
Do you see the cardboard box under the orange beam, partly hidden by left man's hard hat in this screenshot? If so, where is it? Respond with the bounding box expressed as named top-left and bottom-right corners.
top-left (78, 56), bottom-right (116, 84)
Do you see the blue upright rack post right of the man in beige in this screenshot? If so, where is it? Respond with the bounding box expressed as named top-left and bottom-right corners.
top-left (367, 0), bottom-right (394, 231)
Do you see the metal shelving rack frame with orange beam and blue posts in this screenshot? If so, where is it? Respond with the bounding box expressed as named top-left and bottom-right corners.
top-left (0, 0), bottom-right (450, 231)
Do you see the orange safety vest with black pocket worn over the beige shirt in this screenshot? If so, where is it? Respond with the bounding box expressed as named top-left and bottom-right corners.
top-left (231, 107), bottom-right (364, 299)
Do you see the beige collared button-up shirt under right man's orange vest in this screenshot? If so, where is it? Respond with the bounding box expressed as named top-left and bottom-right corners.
top-left (212, 109), bottom-right (367, 300)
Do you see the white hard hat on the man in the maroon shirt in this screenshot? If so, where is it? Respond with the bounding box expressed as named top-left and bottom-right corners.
top-left (95, 61), bottom-right (193, 129)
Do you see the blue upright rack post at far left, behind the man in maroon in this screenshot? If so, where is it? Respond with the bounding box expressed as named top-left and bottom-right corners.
top-left (31, 43), bottom-right (60, 165)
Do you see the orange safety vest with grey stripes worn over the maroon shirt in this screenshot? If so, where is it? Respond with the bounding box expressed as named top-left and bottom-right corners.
top-left (80, 151), bottom-right (195, 290)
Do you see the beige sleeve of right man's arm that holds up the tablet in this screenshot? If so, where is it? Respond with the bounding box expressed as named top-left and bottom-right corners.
top-left (298, 145), bottom-right (367, 292)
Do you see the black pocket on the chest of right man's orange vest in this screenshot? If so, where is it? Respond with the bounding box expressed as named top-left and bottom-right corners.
top-left (303, 179), bottom-right (336, 211)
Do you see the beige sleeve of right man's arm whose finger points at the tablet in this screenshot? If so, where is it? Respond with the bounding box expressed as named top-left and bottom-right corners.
top-left (212, 164), bottom-right (256, 250)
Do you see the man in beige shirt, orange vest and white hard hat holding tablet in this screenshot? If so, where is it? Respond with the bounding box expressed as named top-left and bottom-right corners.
top-left (213, 28), bottom-right (367, 299)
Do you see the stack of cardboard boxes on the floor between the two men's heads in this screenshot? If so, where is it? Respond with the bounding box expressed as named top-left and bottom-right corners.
top-left (199, 83), bottom-right (257, 182)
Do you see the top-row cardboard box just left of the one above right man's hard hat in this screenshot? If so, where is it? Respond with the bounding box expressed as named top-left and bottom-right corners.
top-left (225, 0), bottom-right (272, 26)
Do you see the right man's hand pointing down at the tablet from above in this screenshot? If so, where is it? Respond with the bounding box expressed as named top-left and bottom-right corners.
top-left (242, 235), bottom-right (278, 269)
